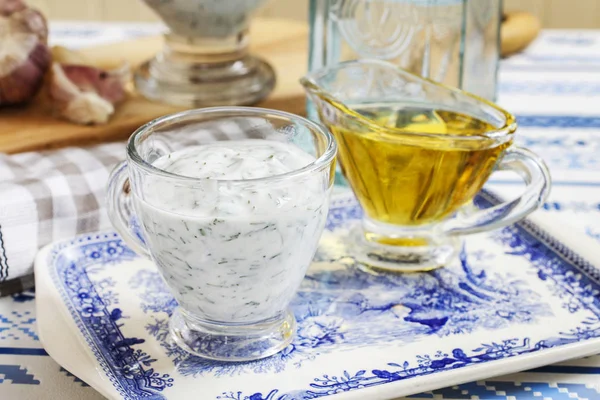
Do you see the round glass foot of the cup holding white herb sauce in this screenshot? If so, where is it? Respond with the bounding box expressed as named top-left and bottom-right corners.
top-left (170, 307), bottom-right (296, 362)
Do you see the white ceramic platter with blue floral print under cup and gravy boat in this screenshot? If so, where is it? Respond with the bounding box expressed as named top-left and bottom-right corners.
top-left (35, 194), bottom-right (600, 400)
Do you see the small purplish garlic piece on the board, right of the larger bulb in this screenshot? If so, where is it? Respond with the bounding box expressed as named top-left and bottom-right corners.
top-left (49, 63), bottom-right (129, 124)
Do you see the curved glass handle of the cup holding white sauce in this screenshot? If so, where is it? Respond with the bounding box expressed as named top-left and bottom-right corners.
top-left (106, 161), bottom-right (150, 258)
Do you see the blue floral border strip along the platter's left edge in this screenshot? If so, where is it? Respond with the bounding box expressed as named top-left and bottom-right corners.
top-left (49, 233), bottom-right (173, 399)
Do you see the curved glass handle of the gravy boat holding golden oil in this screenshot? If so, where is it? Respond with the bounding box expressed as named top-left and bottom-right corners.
top-left (442, 146), bottom-right (551, 235)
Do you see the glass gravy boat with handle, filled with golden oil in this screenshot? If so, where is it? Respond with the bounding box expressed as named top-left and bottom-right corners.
top-left (301, 60), bottom-right (550, 271)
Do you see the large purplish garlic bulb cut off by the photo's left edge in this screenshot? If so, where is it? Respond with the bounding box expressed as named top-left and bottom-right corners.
top-left (0, 0), bottom-right (51, 107)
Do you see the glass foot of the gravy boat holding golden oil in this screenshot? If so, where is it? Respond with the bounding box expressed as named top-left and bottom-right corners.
top-left (349, 221), bottom-right (461, 272)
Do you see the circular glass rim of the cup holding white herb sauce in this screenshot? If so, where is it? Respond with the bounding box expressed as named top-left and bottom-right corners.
top-left (127, 106), bottom-right (337, 184)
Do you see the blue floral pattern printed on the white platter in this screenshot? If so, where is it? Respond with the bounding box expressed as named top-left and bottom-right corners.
top-left (49, 192), bottom-right (600, 400)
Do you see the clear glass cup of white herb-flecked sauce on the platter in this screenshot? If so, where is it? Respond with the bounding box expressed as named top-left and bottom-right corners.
top-left (108, 107), bottom-right (336, 361)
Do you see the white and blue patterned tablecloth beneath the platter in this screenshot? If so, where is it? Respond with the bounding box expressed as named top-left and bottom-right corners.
top-left (0, 23), bottom-right (600, 400)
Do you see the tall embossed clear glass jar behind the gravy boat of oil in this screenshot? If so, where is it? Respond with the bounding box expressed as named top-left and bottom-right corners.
top-left (309, 0), bottom-right (502, 101)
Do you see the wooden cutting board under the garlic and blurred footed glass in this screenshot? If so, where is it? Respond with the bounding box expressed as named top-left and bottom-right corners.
top-left (0, 19), bottom-right (308, 153)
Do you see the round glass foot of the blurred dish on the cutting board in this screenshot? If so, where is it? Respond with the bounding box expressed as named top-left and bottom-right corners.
top-left (134, 33), bottom-right (275, 107)
